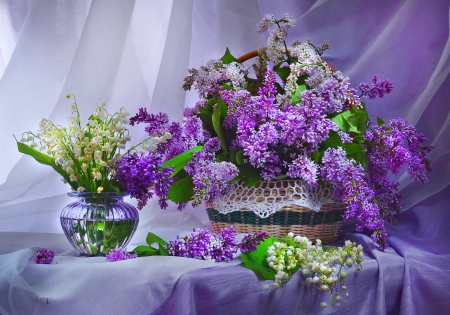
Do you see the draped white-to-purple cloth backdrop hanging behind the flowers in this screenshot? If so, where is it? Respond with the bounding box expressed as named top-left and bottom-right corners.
top-left (0, 0), bottom-right (450, 314)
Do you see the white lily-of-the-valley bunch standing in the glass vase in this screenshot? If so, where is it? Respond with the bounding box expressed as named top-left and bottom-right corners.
top-left (21, 95), bottom-right (131, 192)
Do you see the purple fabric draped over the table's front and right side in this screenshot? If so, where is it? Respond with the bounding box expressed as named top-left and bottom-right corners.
top-left (153, 186), bottom-right (450, 315)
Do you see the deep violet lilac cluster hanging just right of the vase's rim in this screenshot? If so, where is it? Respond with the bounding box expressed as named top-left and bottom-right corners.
top-left (116, 151), bottom-right (174, 209)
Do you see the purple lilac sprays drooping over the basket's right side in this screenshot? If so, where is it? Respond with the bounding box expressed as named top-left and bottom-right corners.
top-left (320, 118), bottom-right (432, 249)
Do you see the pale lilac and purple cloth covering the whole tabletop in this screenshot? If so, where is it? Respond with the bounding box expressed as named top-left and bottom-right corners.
top-left (0, 188), bottom-right (450, 315)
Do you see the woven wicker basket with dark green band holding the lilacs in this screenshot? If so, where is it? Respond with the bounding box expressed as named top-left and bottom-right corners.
top-left (206, 181), bottom-right (345, 243)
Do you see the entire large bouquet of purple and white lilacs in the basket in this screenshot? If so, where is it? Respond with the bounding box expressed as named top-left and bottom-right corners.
top-left (116, 14), bottom-right (432, 249)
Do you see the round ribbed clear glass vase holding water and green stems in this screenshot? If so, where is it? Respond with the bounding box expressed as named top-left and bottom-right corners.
top-left (61, 192), bottom-right (139, 256)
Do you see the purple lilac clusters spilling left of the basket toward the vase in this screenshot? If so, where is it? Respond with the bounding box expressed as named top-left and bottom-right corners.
top-left (116, 108), bottom-right (239, 210)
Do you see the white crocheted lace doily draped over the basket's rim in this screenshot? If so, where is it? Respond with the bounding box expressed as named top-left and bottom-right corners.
top-left (213, 180), bottom-right (337, 218)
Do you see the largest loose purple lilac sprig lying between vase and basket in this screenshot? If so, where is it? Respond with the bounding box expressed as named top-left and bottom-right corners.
top-left (166, 227), bottom-right (237, 262)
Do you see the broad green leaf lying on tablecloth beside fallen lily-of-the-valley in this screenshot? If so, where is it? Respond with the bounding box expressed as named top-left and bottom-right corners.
top-left (242, 237), bottom-right (276, 280)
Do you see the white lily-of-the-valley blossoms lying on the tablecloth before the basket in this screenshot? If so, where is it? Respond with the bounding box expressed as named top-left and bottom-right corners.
top-left (265, 232), bottom-right (364, 307)
